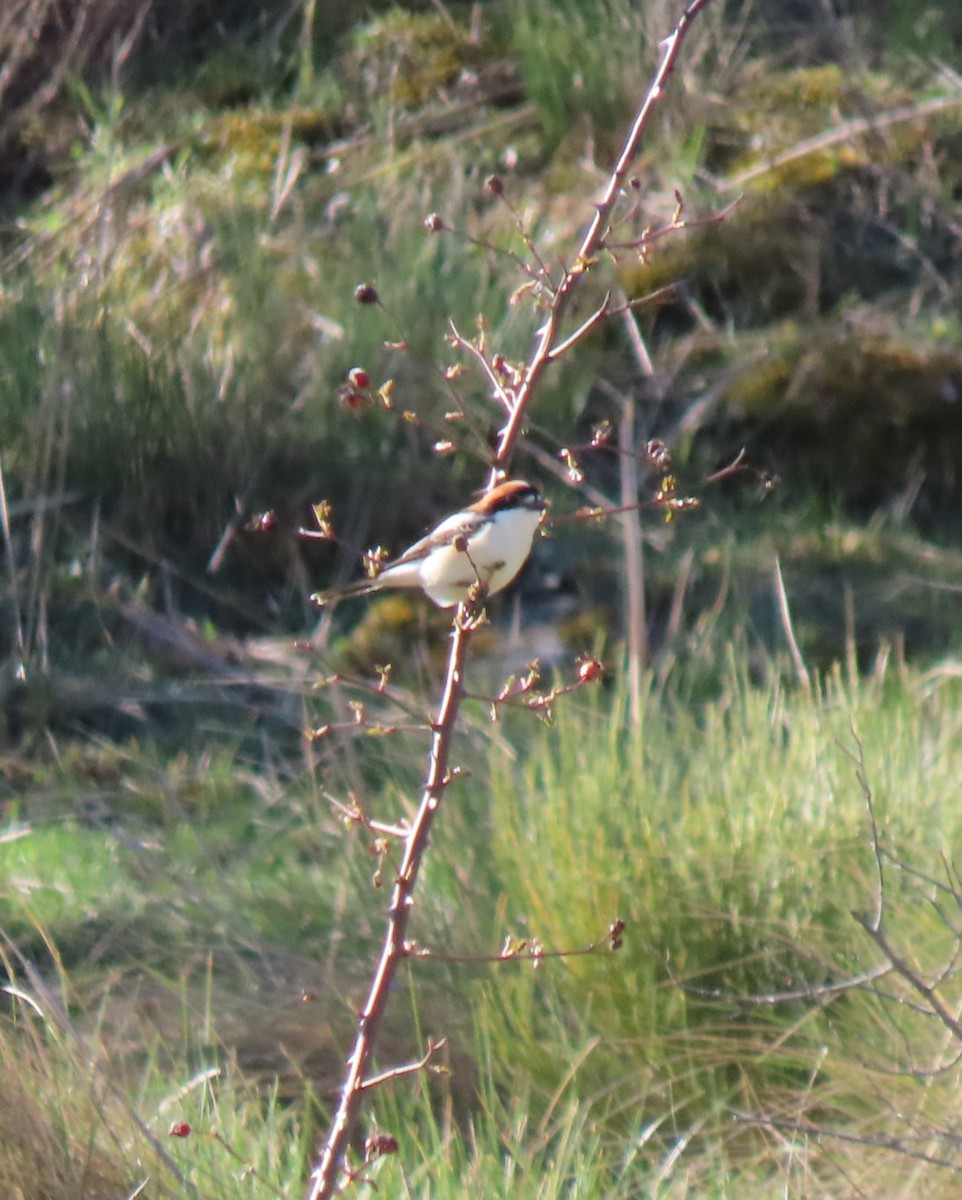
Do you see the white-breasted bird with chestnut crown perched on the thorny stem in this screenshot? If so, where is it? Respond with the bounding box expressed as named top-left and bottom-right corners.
top-left (311, 479), bottom-right (545, 608)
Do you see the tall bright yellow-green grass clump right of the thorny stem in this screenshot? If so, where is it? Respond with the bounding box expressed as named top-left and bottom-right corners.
top-left (472, 662), bottom-right (962, 1114)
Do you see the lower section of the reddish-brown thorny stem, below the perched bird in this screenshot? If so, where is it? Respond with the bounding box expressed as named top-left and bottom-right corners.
top-left (307, 608), bottom-right (474, 1200)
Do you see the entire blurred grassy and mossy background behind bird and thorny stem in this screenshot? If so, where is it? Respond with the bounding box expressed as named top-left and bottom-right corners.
top-left (0, 0), bottom-right (962, 1200)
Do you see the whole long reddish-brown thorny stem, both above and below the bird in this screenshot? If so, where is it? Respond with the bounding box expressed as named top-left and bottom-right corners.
top-left (307, 0), bottom-right (709, 1200)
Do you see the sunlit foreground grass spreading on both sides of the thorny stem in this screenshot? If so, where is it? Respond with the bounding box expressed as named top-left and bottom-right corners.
top-left (0, 662), bottom-right (962, 1200)
